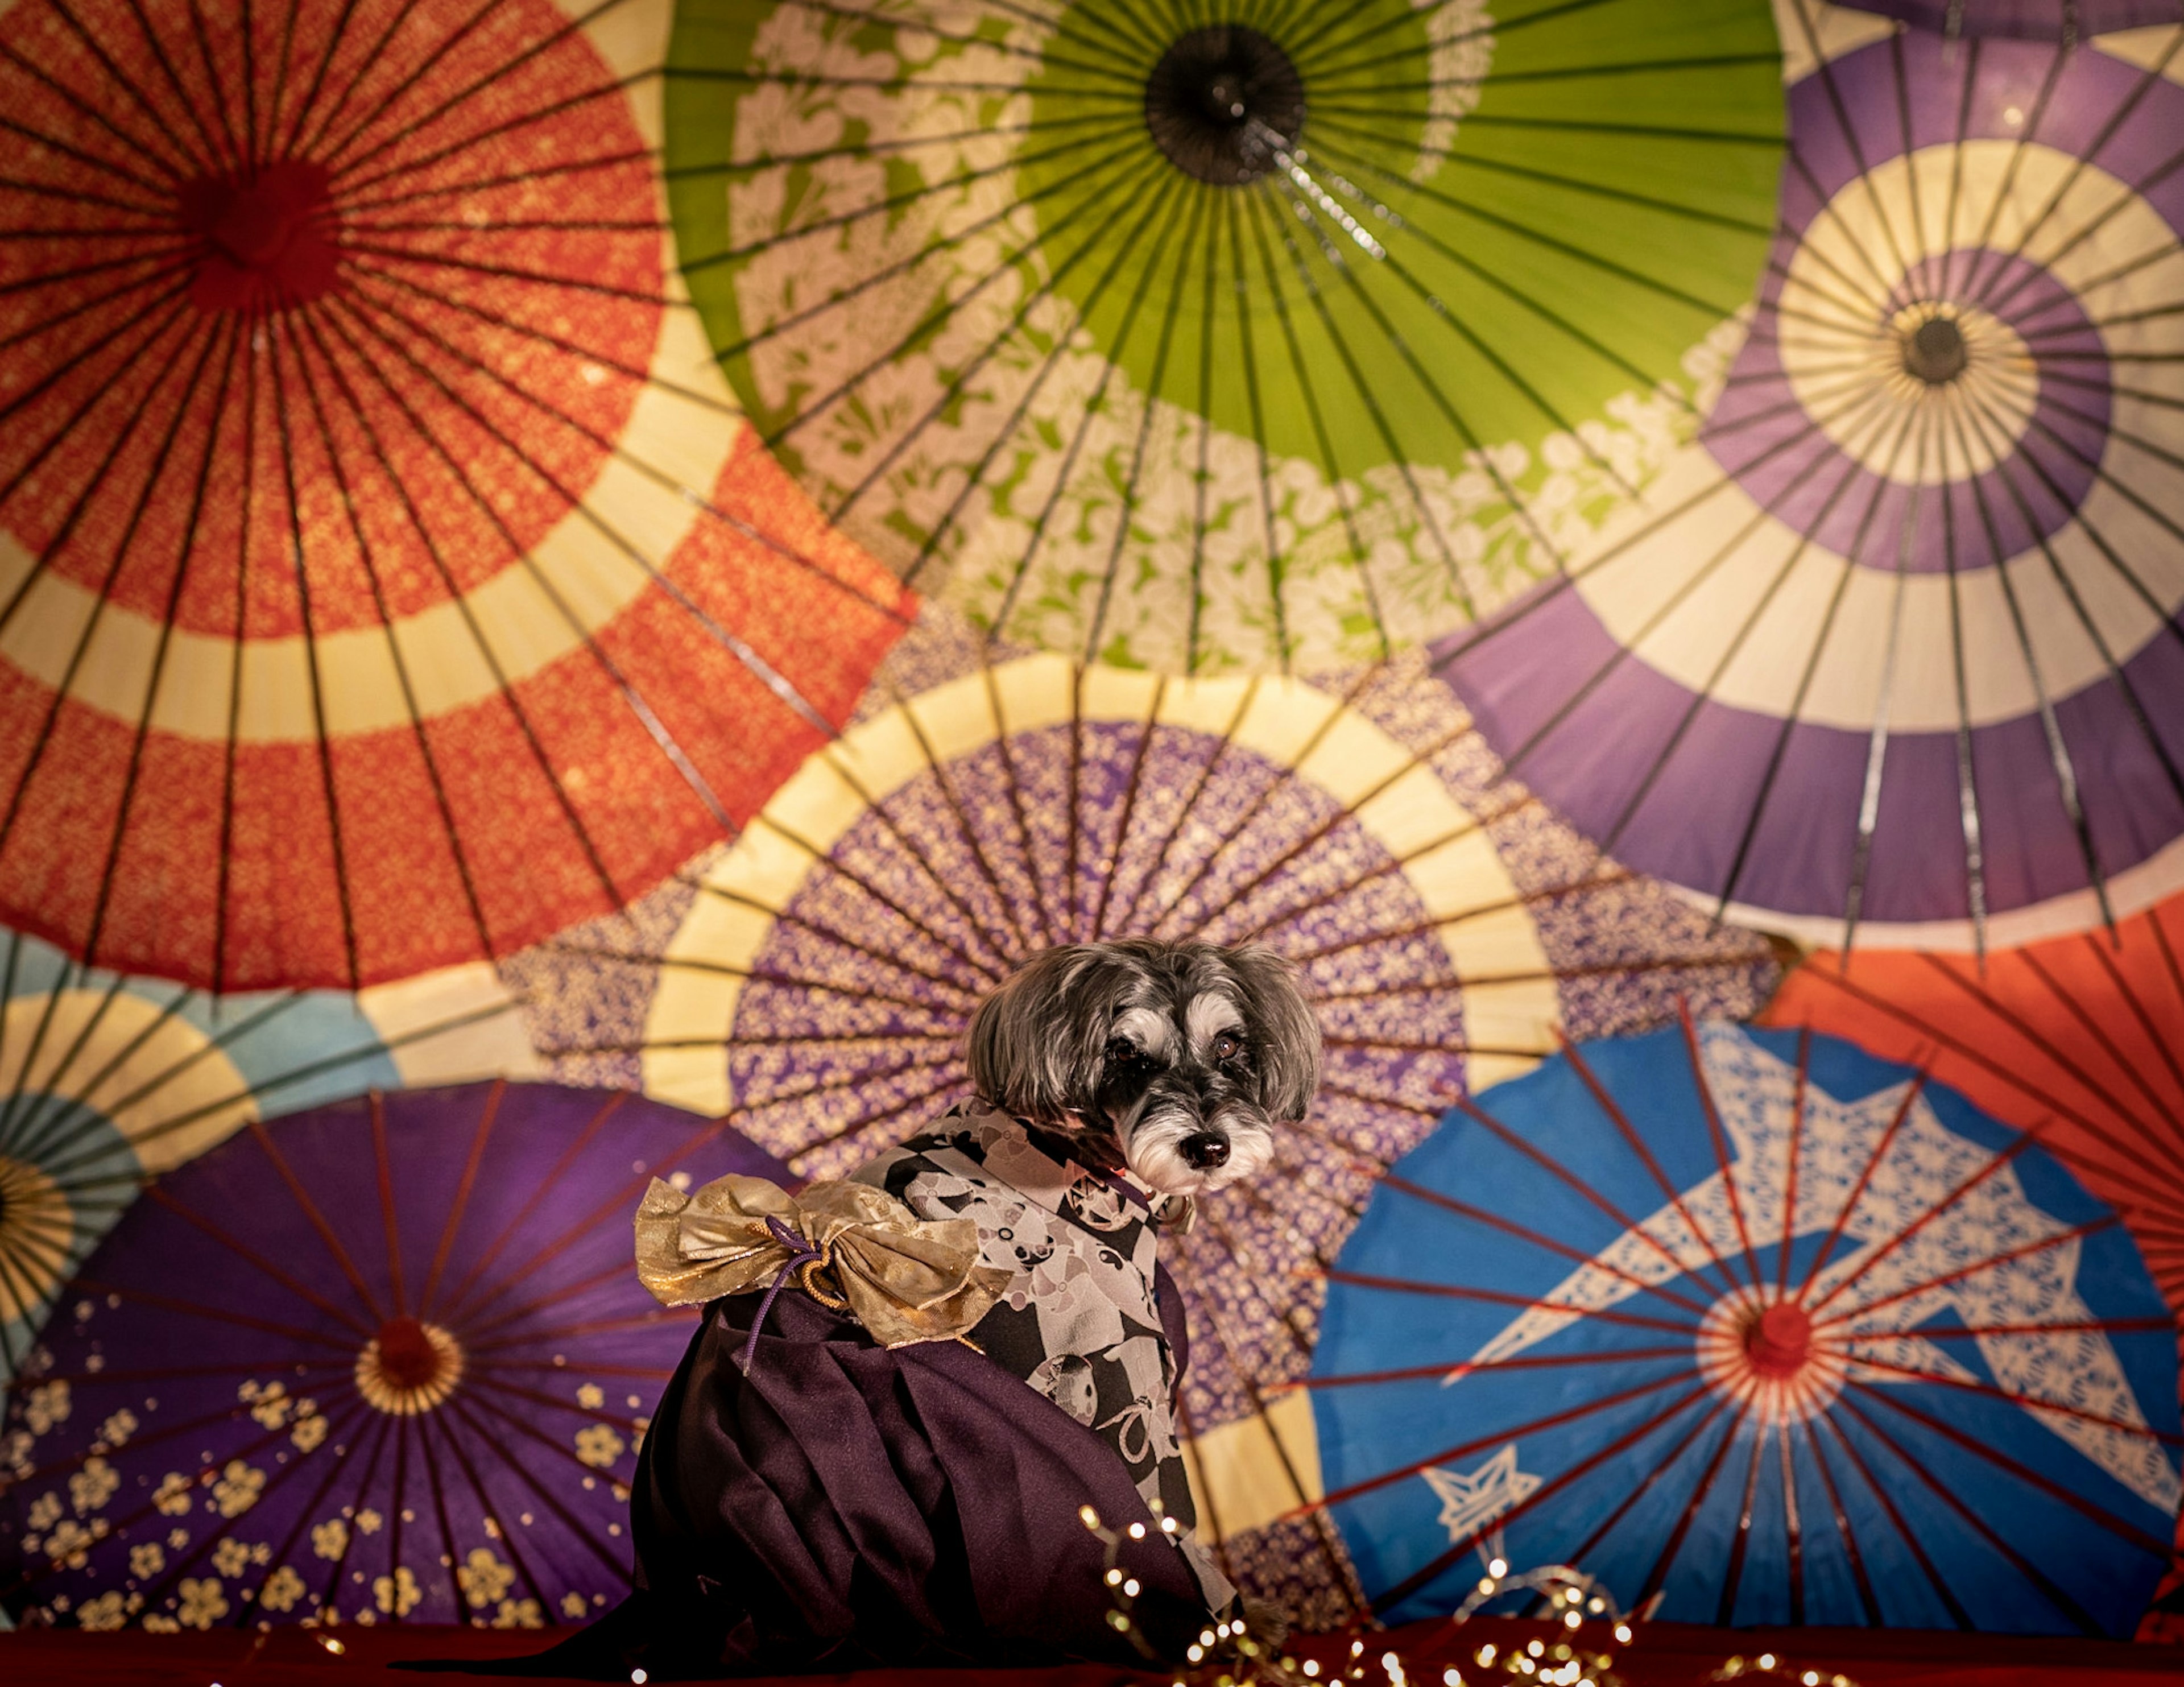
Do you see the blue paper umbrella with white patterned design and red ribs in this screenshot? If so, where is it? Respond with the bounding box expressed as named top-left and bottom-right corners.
top-left (1310, 1023), bottom-right (2184, 1635)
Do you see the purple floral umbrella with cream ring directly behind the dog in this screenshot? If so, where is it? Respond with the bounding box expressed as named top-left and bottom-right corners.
top-left (507, 634), bottom-right (1776, 1622)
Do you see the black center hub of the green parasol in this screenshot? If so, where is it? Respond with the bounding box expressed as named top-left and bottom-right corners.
top-left (1144, 24), bottom-right (1304, 188)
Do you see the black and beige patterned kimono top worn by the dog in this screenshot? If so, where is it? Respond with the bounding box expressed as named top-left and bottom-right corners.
top-left (852, 1101), bottom-right (1236, 1611)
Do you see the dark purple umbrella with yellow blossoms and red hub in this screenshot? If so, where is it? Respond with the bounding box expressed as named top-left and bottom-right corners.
top-left (0, 1084), bottom-right (782, 1630)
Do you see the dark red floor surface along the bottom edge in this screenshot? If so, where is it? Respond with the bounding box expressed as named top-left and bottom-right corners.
top-left (0, 1619), bottom-right (2184, 1687)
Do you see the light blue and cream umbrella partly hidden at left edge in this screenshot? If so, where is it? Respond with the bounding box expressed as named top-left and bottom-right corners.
top-left (0, 931), bottom-right (537, 1383)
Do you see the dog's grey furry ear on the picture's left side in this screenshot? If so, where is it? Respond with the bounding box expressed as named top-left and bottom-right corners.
top-left (970, 944), bottom-right (1116, 1126)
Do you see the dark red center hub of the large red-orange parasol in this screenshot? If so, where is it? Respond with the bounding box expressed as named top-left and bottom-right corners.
top-left (179, 159), bottom-right (341, 311)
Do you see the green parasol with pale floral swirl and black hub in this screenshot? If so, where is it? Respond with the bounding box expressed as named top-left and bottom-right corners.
top-left (666, 0), bottom-right (1782, 671)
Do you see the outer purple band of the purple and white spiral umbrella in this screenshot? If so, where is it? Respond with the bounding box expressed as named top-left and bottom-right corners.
top-left (1440, 588), bottom-right (2184, 922)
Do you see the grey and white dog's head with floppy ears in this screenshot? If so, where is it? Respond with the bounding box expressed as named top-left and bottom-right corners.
top-left (970, 940), bottom-right (1319, 1196)
